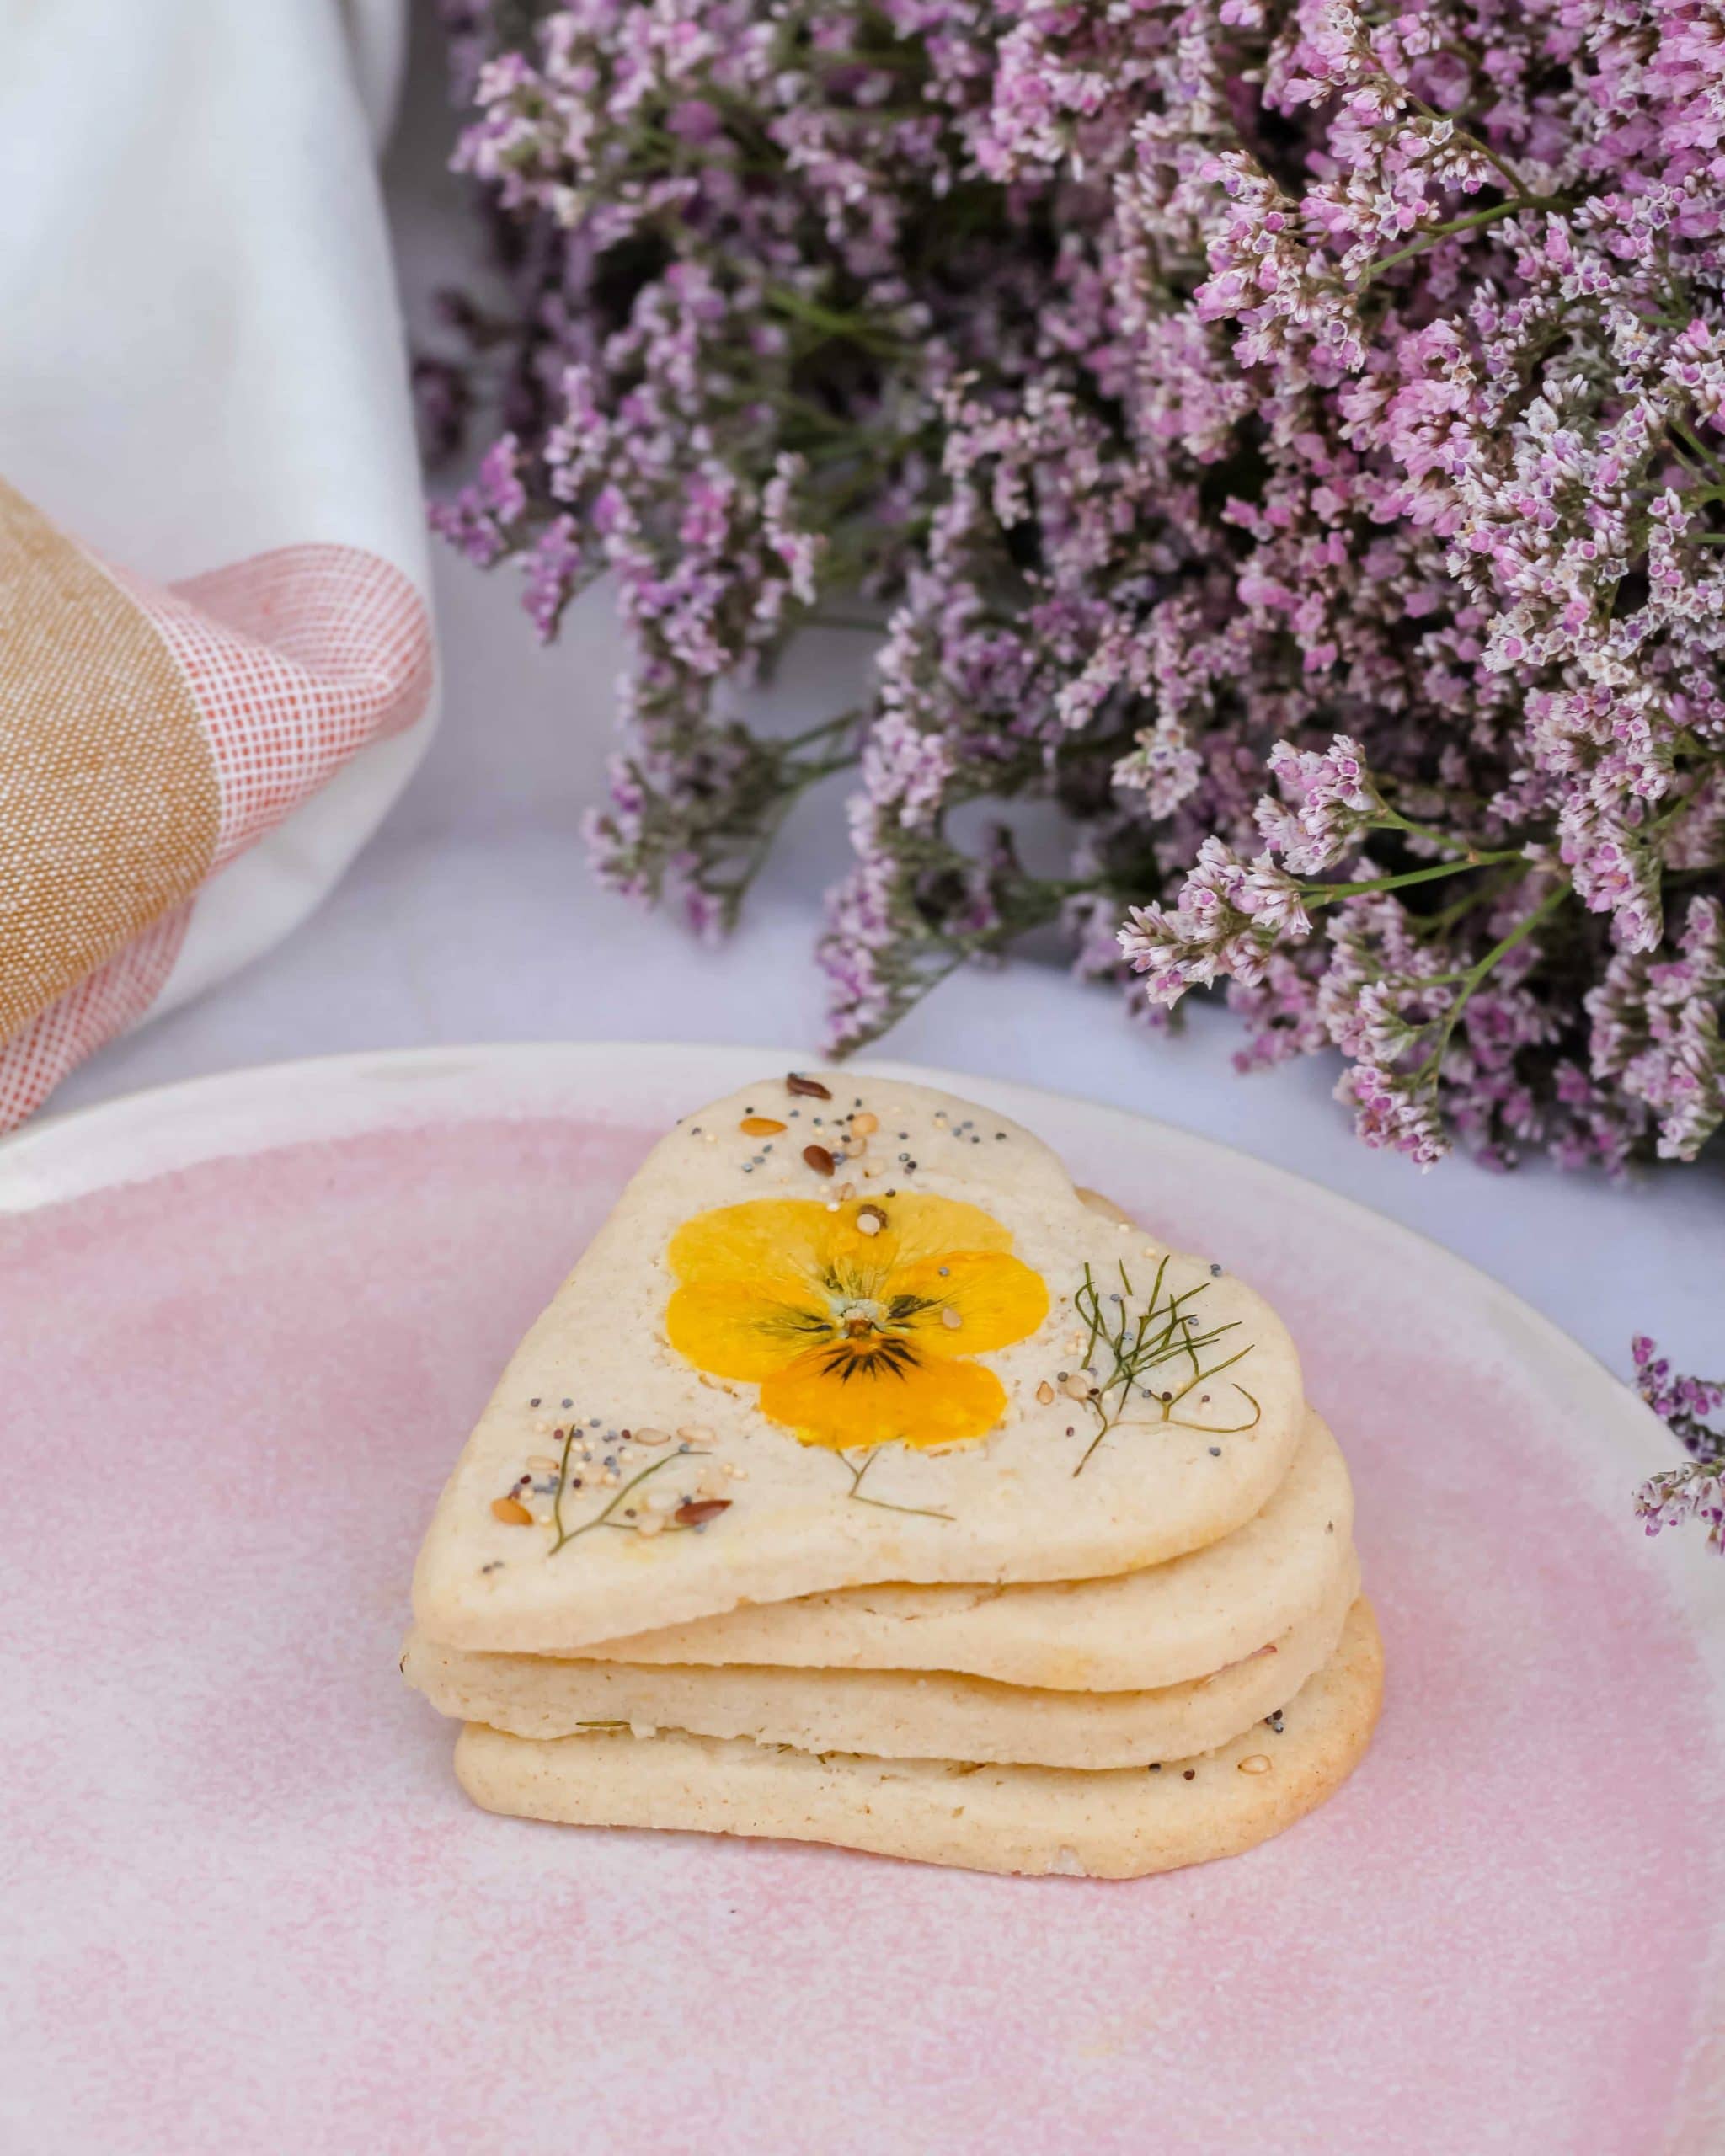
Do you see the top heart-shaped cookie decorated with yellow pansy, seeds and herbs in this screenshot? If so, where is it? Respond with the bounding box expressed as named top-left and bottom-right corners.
top-left (414, 1071), bottom-right (1302, 1654)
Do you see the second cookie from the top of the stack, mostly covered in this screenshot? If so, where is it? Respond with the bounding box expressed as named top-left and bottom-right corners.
top-left (585, 1414), bottom-right (1354, 1693)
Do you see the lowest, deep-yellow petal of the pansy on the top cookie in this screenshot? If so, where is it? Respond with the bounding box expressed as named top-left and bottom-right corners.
top-left (761, 1348), bottom-right (1007, 1451)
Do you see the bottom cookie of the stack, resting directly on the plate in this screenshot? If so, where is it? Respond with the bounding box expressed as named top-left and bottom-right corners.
top-left (455, 1600), bottom-right (1382, 1878)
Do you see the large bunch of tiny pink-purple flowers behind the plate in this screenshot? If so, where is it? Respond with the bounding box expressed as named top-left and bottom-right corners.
top-left (420, 0), bottom-right (1725, 1169)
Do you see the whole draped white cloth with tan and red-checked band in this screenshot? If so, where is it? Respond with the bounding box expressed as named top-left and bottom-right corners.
top-left (0, 0), bottom-right (435, 1129)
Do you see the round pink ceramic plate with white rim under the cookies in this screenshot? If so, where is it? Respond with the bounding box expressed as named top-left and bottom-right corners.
top-left (0, 1048), bottom-right (1725, 2156)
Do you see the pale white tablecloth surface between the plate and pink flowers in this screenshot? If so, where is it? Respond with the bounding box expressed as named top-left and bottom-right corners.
top-left (54, 25), bottom-right (1725, 1374)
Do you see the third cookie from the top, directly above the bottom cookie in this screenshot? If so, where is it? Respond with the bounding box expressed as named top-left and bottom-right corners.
top-left (401, 1563), bottom-right (1359, 1768)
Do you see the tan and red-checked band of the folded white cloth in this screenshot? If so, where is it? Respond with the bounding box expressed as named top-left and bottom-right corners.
top-left (0, 481), bottom-right (431, 1129)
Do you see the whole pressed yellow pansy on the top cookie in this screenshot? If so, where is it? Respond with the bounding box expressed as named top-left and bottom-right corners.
top-left (666, 1197), bottom-right (1048, 1451)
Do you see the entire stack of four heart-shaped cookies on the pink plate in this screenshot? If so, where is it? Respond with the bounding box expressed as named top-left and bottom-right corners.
top-left (403, 1074), bottom-right (1382, 1878)
